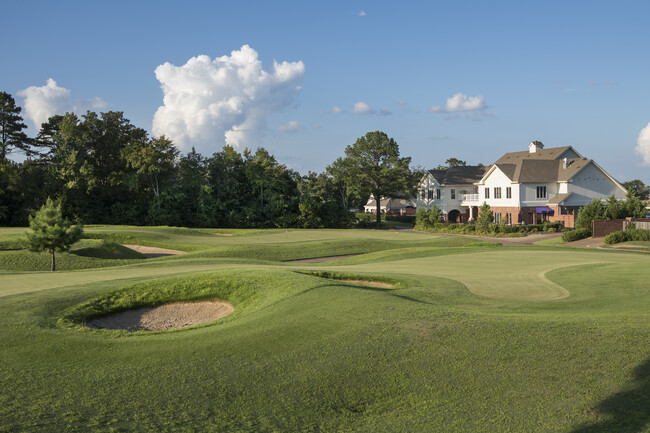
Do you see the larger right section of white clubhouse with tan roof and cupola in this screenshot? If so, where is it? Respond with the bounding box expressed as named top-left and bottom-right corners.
top-left (466, 141), bottom-right (627, 227)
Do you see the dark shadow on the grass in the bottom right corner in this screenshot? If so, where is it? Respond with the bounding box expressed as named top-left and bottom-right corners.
top-left (572, 358), bottom-right (650, 433)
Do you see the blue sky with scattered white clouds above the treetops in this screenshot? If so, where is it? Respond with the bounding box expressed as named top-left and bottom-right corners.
top-left (5, 0), bottom-right (650, 184)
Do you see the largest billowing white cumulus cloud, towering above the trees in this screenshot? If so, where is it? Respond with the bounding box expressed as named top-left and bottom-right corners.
top-left (153, 45), bottom-right (305, 151)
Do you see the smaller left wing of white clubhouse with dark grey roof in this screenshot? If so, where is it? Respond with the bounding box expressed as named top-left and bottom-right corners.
top-left (417, 166), bottom-right (489, 222)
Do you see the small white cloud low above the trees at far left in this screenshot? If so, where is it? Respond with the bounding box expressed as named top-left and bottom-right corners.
top-left (17, 78), bottom-right (106, 128)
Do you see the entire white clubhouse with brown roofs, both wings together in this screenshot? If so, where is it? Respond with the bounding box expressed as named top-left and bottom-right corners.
top-left (417, 141), bottom-right (627, 227)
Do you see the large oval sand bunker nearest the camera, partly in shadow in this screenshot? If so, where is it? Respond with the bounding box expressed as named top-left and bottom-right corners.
top-left (88, 301), bottom-right (234, 331)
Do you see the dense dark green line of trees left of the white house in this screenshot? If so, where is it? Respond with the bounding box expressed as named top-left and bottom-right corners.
top-left (0, 92), bottom-right (419, 228)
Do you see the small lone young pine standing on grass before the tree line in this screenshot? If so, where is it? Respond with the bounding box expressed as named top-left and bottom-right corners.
top-left (27, 197), bottom-right (83, 272)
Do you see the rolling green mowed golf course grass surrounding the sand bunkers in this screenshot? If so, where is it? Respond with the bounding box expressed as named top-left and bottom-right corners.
top-left (0, 224), bottom-right (650, 433)
